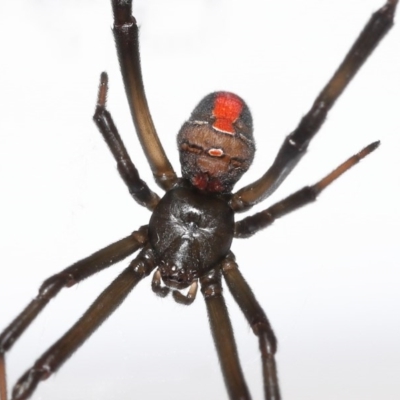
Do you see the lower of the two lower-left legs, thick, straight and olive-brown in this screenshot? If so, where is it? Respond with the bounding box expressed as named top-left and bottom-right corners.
top-left (12, 247), bottom-right (155, 400)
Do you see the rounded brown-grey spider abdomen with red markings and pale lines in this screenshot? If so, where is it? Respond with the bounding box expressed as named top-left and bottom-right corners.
top-left (178, 92), bottom-right (255, 193)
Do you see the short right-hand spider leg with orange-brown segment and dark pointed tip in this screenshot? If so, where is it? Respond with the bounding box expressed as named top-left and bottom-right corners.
top-left (234, 142), bottom-right (379, 238)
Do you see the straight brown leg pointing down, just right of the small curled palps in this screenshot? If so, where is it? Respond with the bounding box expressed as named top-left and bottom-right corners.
top-left (200, 269), bottom-right (251, 400)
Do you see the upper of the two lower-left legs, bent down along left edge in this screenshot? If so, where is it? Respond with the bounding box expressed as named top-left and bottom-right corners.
top-left (0, 226), bottom-right (147, 400)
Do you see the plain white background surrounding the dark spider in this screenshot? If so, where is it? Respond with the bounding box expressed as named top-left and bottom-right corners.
top-left (0, 0), bottom-right (400, 400)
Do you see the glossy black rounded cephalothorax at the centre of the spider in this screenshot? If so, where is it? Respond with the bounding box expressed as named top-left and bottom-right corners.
top-left (149, 186), bottom-right (234, 289)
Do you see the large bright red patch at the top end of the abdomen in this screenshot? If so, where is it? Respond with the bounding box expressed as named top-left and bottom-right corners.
top-left (213, 92), bottom-right (243, 135)
